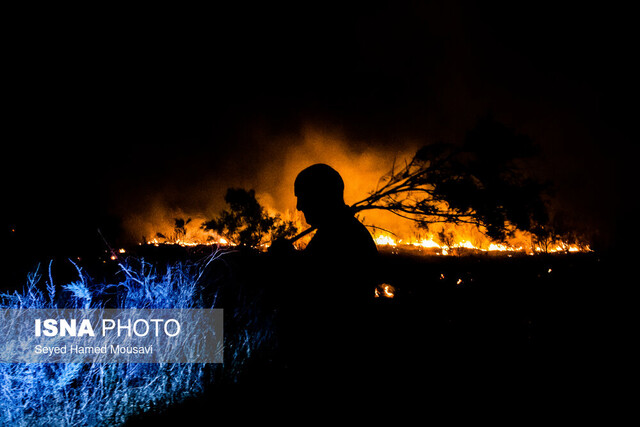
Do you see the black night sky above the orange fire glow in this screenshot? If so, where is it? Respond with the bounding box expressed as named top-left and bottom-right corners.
top-left (2, 1), bottom-right (637, 260)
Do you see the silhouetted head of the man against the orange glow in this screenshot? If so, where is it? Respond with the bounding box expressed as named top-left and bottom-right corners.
top-left (294, 163), bottom-right (345, 227)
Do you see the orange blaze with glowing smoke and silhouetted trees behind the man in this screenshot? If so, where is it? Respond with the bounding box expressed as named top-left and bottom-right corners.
top-left (121, 117), bottom-right (597, 262)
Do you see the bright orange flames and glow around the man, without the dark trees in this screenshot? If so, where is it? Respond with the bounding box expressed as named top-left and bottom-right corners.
top-left (129, 127), bottom-right (591, 255)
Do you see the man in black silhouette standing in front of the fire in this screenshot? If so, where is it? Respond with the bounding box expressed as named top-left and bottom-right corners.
top-left (272, 164), bottom-right (378, 381)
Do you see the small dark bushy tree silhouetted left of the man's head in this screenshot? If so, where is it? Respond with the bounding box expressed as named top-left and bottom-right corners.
top-left (202, 188), bottom-right (297, 247)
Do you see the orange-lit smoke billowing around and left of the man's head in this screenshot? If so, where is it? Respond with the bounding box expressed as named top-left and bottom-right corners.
top-left (117, 124), bottom-right (420, 243)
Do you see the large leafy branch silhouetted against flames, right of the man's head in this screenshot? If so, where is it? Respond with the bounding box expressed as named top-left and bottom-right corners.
top-left (352, 116), bottom-right (548, 240)
